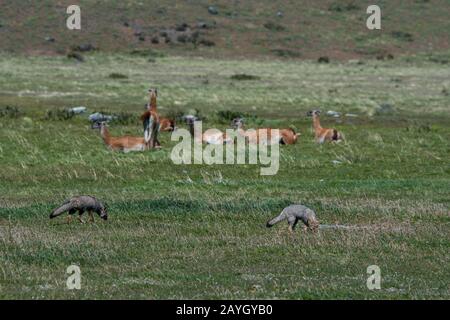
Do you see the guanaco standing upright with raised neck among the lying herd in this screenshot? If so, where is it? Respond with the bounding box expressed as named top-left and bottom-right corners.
top-left (141, 88), bottom-right (161, 148)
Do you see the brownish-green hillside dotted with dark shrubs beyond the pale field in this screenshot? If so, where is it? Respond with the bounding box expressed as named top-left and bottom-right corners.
top-left (0, 0), bottom-right (450, 59)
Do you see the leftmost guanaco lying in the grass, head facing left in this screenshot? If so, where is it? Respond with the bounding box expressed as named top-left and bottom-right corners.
top-left (92, 121), bottom-right (149, 153)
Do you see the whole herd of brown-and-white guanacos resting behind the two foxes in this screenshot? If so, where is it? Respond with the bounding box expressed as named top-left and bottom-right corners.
top-left (92, 89), bottom-right (343, 152)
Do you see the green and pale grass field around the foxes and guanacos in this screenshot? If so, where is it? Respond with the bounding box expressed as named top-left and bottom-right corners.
top-left (0, 53), bottom-right (450, 299)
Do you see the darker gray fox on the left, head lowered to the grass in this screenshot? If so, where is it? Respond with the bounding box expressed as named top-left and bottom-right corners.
top-left (50, 196), bottom-right (108, 223)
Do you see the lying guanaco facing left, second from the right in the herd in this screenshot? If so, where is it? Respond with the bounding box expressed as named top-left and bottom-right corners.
top-left (231, 118), bottom-right (300, 144)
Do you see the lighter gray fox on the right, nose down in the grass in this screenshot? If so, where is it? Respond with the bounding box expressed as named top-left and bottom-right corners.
top-left (266, 204), bottom-right (319, 232)
